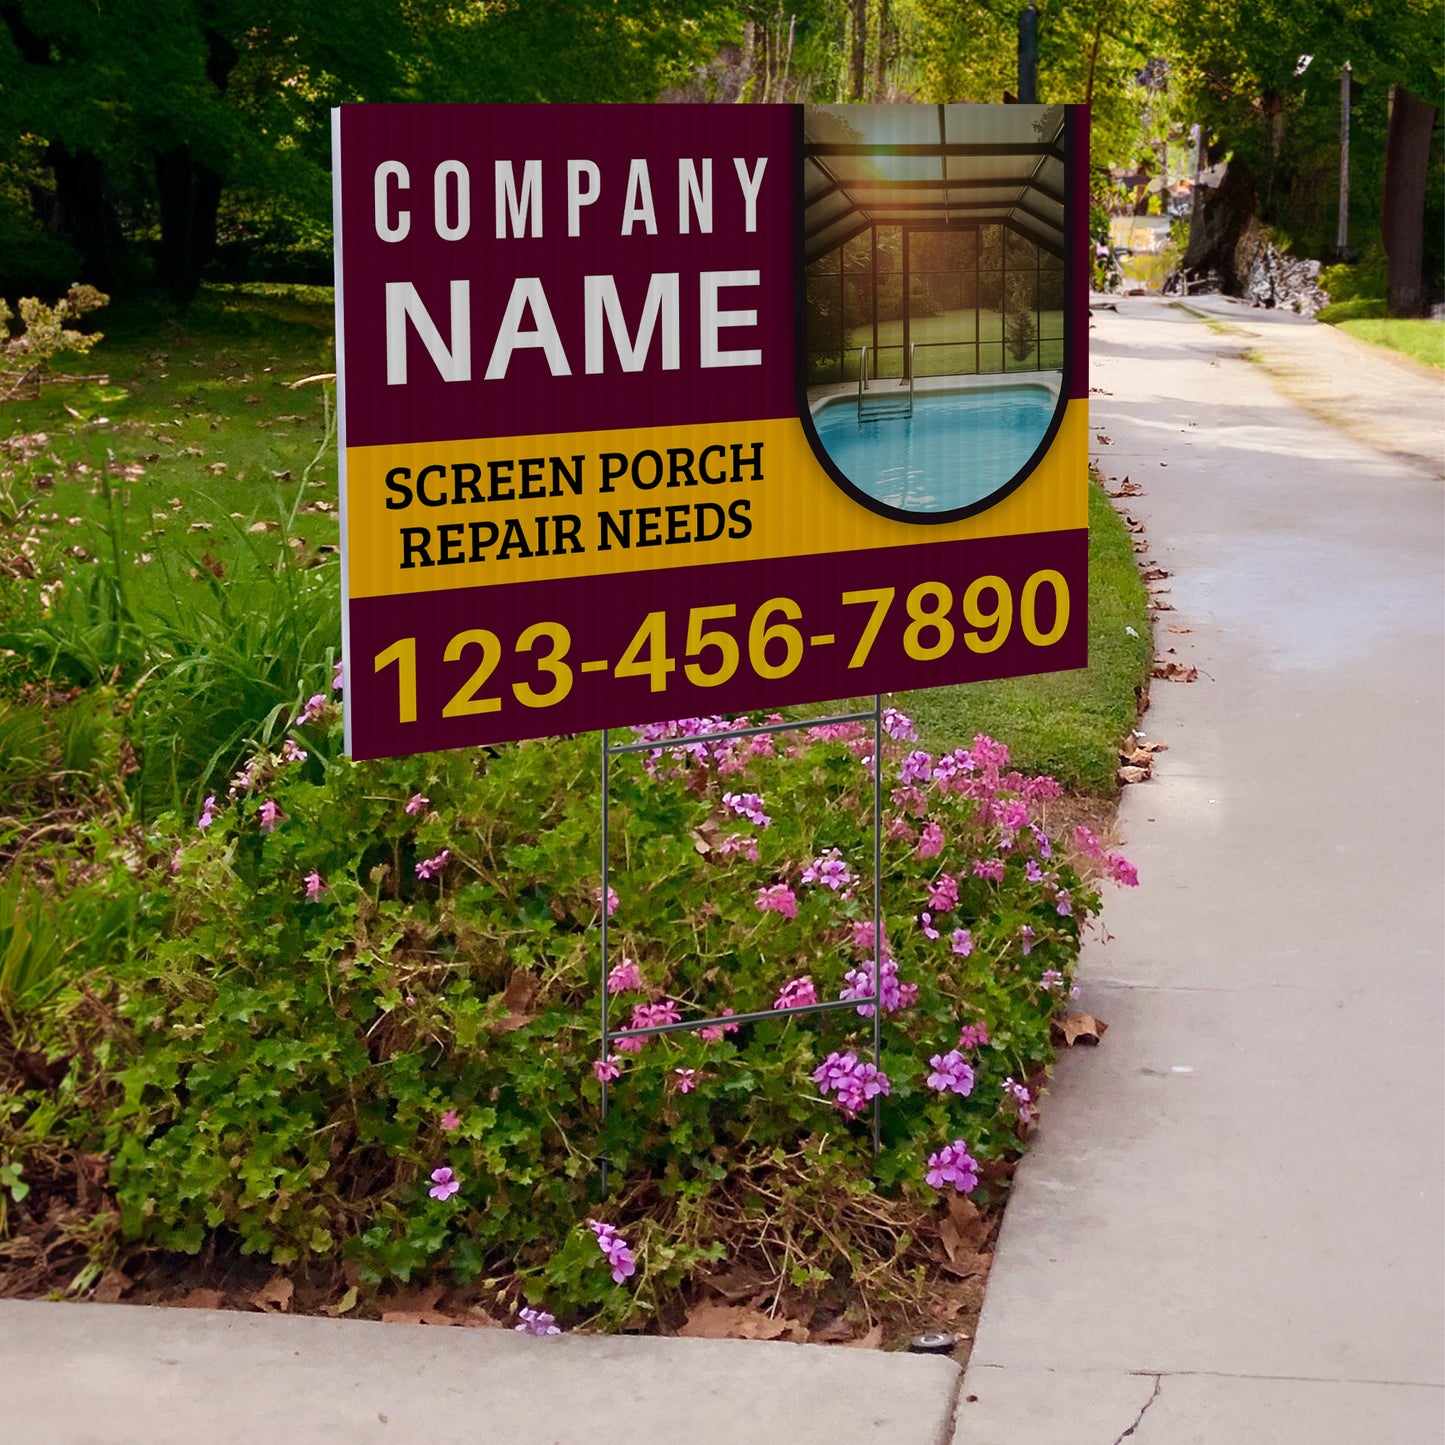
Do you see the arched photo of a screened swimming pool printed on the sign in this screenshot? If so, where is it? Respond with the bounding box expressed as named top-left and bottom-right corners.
top-left (802, 105), bottom-right (1066, 522)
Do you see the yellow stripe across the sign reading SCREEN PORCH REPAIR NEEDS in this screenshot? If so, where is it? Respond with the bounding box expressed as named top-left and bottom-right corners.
top-left (345, 400), bottom-right (1088, 597)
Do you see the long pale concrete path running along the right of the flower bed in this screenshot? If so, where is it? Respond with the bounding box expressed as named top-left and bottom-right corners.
top-left (955, 301), bottom-right (1445, 1445)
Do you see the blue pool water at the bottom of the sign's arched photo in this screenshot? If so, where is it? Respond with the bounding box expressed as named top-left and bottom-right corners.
top-left (814, 384), bottom-right (1053, 512)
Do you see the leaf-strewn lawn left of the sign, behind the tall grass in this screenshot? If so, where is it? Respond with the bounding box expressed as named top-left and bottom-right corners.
top-left (0, 278), bottom-right (337, 630)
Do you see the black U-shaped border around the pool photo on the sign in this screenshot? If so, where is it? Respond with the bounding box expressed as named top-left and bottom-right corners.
top-left (793, 105), bottom-right (1081, 526)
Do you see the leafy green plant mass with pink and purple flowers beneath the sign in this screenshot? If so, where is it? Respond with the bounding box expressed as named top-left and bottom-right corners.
top-left (84, 698), bottom-right (1131, 1324)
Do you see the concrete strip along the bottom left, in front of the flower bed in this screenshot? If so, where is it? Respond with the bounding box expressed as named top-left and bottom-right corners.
top-left (0, 1301), bottom-right (958, 1445)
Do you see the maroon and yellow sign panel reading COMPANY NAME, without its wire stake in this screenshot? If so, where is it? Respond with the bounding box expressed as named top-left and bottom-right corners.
top-left (332, 105), bottom-right (1088, 757)
